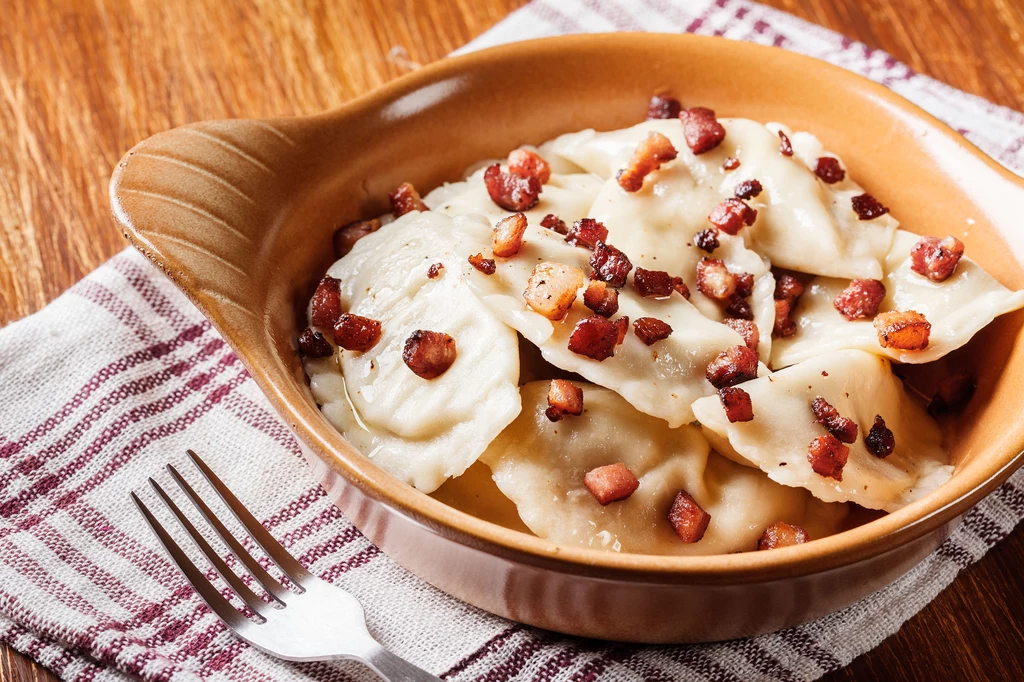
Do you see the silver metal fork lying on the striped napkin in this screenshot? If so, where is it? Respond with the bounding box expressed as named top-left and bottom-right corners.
top-left (131, 450), bottom-right (438, 682)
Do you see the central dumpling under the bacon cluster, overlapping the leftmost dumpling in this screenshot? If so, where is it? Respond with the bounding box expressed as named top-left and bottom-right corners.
top-left (456, 212), bottom-right (743, 426)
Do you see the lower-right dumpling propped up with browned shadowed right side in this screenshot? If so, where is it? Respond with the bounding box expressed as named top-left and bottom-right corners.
top-left (693, 350), bottom-right (952, 511)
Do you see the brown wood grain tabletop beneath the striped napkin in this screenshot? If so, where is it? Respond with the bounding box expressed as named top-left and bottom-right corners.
top-left (0, 0), bottom-right (1024, 682)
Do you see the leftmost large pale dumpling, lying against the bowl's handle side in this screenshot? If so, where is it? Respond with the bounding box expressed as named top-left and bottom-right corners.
top-left (306, 212), bottom-right (520, 493)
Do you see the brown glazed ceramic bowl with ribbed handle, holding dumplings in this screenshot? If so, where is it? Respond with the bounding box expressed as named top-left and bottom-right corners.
top-left (111, 34), bottom-right (1024, 642)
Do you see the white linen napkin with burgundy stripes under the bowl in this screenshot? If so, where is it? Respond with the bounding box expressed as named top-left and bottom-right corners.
top-left (0, 0), bottom-right (1024, 682)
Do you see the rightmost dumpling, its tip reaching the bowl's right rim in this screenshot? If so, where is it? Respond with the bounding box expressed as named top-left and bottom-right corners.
top-left (771, 229), bottom-right (1024, 369)
